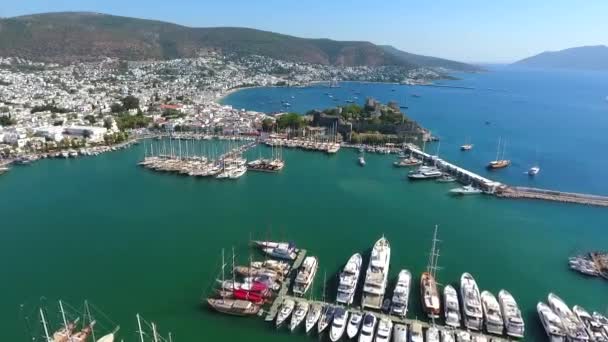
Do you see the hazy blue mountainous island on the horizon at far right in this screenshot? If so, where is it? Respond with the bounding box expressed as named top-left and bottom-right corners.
top-left (512, 45), bottom-right (608, 70)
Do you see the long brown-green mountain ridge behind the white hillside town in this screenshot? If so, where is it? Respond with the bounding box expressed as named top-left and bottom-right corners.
top-left (0, 12), bottom-right (480, 71)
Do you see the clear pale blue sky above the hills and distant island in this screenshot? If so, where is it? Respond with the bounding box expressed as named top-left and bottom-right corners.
top-left (0, 0), bottom-right (608, 62)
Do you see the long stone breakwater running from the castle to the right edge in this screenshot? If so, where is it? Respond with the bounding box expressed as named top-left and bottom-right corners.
top-left (406, 144), bottom-right (608, 207)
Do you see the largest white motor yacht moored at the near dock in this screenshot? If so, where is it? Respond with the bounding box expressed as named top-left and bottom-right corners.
top-left (361, 236), bottom-right (391, 309)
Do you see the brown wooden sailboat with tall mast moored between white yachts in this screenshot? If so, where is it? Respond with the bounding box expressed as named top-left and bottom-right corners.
top-left (420, 226), bottom-right (441, 319)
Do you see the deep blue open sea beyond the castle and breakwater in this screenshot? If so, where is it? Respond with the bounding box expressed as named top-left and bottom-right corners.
top-left (224, 67), bottom-right (608, 195)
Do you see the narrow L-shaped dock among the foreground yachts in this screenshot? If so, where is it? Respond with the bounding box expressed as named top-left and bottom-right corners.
top-left (264, 249), bottom-right (509, 342)
